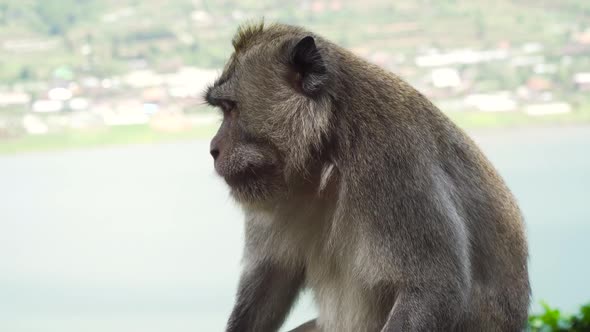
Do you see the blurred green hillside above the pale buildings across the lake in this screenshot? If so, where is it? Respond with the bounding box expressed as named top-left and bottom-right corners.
top-left (0, 0), bottom-right (590, 82)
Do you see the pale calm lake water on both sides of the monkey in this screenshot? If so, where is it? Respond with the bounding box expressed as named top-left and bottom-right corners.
top-left (0, 127), bottom-right (590, 332)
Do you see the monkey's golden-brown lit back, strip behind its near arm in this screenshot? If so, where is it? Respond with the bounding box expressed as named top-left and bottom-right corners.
top-left (398, 87), bottom-right (530, 331)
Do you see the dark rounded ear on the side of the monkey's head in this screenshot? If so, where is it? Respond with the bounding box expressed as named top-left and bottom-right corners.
top-left (290, 36), bottom-right (328, 95)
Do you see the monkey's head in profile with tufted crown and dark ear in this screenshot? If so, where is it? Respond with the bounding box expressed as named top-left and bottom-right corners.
top-left (205, 24), bottom-right (333, 203)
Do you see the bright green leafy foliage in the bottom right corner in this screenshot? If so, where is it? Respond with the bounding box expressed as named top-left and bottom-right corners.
top-left (529, 303), bottom-right (590, 332)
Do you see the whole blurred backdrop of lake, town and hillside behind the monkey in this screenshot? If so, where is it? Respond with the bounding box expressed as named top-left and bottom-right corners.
top-left (0, 0), bottom-right (590, 332)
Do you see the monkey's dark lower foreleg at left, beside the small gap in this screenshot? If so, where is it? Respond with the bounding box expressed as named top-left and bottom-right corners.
top-left (226, 262), bottom-right (304, 332)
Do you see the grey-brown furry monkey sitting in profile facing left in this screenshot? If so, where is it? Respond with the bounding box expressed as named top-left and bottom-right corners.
top-left (204, 23), bottom-right (530, 332)
